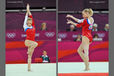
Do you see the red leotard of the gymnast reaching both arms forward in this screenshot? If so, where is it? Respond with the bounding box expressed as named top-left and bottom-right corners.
top-left (76, 19), bottom-right (93, 42)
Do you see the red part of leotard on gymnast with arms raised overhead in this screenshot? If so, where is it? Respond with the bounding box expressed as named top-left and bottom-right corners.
top-left (26, 15), bottom-right (35, 41)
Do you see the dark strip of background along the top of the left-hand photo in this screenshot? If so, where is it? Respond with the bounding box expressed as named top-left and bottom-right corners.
top-left (6, 0), bottom-right (56, 9)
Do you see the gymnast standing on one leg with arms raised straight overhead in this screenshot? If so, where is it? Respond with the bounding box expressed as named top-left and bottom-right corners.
top-left (23, 4), bottom-right (38, 71)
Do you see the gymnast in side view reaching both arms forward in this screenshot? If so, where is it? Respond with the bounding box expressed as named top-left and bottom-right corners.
top-left (66, 9), bottom-right (94, 71)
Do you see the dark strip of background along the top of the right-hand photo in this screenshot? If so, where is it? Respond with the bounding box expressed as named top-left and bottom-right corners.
top-left (58, 0), bottom-right (108, 11)
